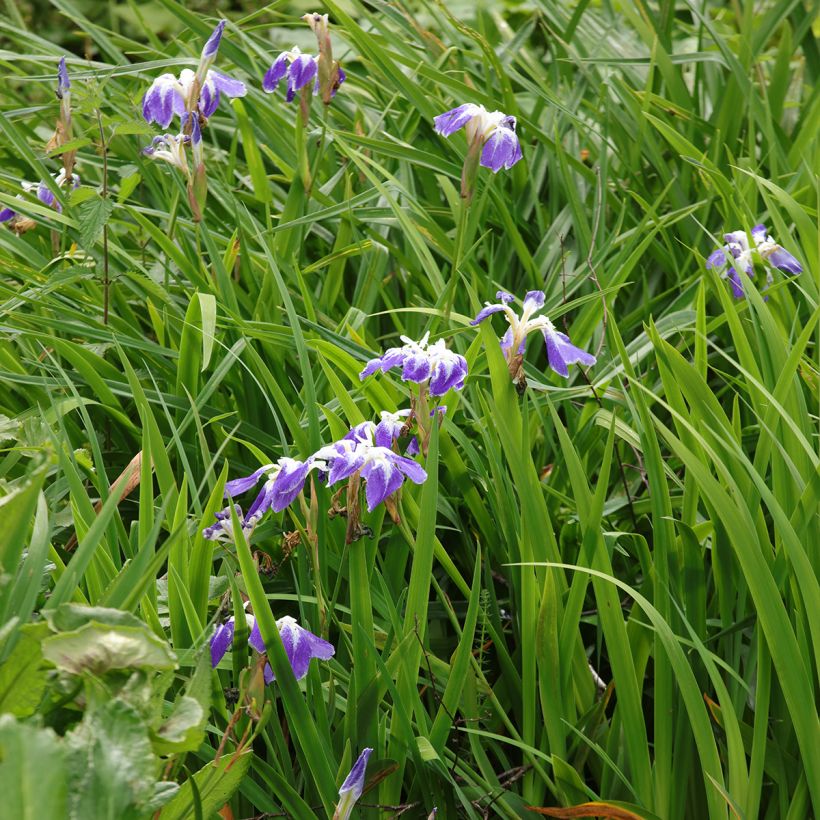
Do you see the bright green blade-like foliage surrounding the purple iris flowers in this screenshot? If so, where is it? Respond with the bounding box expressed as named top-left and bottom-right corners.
top-left (0, 0), bottom-right (820, 820)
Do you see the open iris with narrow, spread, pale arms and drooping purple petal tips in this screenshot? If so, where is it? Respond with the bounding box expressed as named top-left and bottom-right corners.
top-left (470, 290), bottom-right (595, 377)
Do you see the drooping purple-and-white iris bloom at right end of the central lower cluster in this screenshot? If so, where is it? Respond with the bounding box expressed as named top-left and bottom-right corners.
top-left (314, 430), bottom-right (427, 512)
